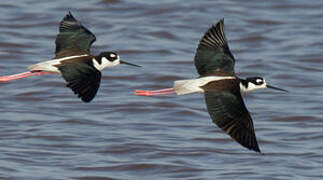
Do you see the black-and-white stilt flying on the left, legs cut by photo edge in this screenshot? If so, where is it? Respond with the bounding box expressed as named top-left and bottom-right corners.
top-left (0, 12), bottom-right (141, 102)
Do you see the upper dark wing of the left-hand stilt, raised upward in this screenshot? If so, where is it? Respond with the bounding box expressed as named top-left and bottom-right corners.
top-left (55, 12), bottom-right (96, 57)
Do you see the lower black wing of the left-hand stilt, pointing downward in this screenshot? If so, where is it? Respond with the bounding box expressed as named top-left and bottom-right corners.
top-left (57, 62), bottom-right (101, 102)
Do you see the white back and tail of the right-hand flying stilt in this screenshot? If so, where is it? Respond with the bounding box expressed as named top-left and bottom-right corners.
top-left (174, 76), bottom-right (236, 95)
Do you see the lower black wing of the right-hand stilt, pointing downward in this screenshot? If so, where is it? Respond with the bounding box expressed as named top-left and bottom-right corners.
top-left (205, 88), bottom-right (260, 152)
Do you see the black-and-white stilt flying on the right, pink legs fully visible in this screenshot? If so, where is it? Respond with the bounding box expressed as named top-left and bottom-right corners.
top-left (135, 19), bottom-right (287, 152)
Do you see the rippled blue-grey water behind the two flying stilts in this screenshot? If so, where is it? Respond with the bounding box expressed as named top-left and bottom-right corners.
top-left (0, 0), bottom-right (323, 180)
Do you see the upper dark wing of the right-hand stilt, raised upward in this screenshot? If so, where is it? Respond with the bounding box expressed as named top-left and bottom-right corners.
top-left (194, 19), bottom-right (235, 76)
